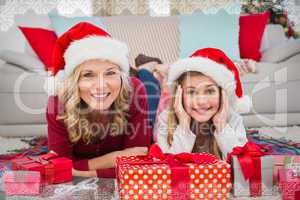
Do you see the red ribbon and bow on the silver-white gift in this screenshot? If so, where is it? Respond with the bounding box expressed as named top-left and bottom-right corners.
top-left (227, 142), bottom-right (265, 196)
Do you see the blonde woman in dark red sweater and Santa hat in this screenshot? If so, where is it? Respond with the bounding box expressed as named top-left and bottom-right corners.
top-left (47, 23), bottom-right (151, 177)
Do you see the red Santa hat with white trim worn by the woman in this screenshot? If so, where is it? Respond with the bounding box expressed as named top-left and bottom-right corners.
top-left (45, 22), bottom-right (129, 95)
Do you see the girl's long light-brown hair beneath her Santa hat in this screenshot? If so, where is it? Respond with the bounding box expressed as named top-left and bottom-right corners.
top-left (167, 71), bottom-right (222, 158)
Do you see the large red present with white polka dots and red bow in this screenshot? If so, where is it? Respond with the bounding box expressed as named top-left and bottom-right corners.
top-left (116, 145), bottom-right (231, 200)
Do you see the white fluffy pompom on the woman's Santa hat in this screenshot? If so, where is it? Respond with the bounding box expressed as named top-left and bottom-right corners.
top-left (44, 70), bottom-right (64, 96)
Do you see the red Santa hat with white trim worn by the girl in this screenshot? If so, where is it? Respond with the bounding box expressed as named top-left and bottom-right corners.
top-left (168, 48), bottom-right (251, 113)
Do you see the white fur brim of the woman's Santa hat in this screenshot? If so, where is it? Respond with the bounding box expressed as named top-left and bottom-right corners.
top-left (64, 36), bottom-right (129, 76)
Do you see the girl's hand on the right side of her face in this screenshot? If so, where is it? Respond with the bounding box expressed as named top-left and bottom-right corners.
top-left (212, 89), bottom-right (229, 133)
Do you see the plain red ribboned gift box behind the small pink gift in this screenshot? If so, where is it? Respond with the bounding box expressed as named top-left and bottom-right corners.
top-left (12, 153), bottom-right (72, 184)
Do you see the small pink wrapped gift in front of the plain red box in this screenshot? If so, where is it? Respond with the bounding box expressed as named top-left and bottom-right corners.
top-left (2, 171), bottom-right (41, 196)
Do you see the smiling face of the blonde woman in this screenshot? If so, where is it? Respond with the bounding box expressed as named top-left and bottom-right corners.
top-left (78, 59), bottom-right (122, 111)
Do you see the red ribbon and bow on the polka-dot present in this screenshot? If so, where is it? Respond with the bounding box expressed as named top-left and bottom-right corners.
top-left (121, 144), bottom-right (219, 200)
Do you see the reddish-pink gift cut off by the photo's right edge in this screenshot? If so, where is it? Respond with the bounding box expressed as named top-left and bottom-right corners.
top-left (279, 169), bottom-right (300, 200)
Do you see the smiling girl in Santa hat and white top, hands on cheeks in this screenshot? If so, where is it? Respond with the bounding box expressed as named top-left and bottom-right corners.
top-left (155, 48), bottom-right (249, 158)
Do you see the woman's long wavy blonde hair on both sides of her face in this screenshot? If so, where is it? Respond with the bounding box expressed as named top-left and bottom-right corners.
top-left (57, 66), bottom-right (132, 144)
